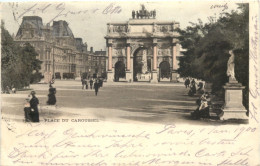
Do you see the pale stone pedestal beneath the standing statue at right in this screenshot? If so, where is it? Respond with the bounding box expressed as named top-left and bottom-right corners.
top-left (220, 81), bottom-right (248, 120)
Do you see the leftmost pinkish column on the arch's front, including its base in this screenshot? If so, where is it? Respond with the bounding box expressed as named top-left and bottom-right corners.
top-left (107, 39), bottom-right (114, 82)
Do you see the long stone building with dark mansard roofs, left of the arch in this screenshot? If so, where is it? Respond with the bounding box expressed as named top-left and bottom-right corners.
top-left (14, 16), bottom-right (91, 82)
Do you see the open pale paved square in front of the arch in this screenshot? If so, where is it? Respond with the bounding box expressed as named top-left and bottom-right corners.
top-left (2, 80), bottom-right (217, 124)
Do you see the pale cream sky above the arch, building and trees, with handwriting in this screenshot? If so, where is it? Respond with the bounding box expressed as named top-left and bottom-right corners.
top-left (0, 1), bottom-right (240, 51)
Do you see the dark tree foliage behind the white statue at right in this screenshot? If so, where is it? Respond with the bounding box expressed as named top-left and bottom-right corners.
top-left (178, 4), bottom-right (249, 108)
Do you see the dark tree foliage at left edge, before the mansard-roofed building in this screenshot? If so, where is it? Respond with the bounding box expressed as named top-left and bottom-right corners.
top-left (1, 22), bottom-right (41, 89)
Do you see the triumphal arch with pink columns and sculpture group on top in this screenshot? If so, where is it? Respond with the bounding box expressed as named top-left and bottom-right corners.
top-left (105, 6), bottom-right (180, 83)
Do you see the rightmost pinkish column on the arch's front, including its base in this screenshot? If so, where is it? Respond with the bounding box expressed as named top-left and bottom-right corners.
top-left (171, 38), bottom-right (178, 82)
